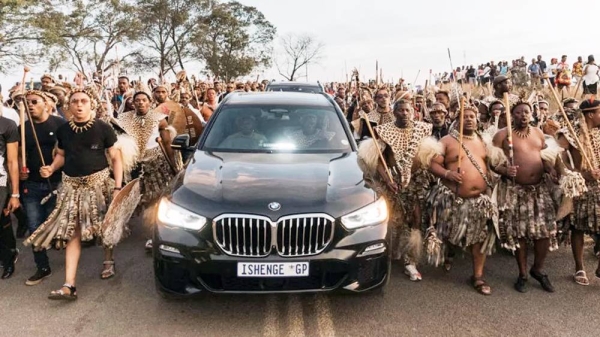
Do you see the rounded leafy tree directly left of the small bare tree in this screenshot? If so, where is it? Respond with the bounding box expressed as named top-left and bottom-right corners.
top-left (193, 1), bottom-right (276, 81)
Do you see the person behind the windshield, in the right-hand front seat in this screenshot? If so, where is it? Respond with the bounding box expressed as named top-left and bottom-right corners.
top-left (288, 113), bottom-right (335, 149)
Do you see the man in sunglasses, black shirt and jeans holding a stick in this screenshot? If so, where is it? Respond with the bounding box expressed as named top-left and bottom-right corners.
top-left (20, 90), bottom-right (67, 286)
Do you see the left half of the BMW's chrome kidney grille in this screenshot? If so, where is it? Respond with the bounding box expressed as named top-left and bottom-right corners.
top-left (213, 216), bottom-right (272, 257)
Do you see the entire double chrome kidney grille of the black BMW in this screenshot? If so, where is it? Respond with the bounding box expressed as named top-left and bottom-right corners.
top-left (213, 214), bottom-right (334, 257)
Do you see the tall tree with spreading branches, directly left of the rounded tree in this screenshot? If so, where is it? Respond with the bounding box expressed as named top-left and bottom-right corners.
top-left (137, 0), bottom-right (212, 76)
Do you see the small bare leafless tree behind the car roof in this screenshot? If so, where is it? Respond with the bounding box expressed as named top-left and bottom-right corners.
top-left (277, 34), bottom-right (324, 81)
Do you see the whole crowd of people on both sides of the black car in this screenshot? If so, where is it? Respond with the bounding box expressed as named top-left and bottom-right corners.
top-left (0, 53), bottom-right (600, 300)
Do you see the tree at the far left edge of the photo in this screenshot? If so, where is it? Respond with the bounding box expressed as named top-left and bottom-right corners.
top-left (0, 0), bottom-right (40, 73)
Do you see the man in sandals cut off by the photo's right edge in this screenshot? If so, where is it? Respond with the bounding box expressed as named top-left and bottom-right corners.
top-left (557, 97), bottom-right (600, 286)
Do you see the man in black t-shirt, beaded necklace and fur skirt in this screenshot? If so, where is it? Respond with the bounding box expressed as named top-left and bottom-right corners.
top-left (24, 88), bottom-right (123, 300)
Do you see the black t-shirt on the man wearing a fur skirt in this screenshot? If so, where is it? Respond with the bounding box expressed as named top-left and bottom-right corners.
top-left (57, 119), bottom-right (117, 177)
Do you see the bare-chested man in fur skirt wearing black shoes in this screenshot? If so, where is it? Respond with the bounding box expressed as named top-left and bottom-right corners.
top-left (493, 101), bottom-right (556, 292)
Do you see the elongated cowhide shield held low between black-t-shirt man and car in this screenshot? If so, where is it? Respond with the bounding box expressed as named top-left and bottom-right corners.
top-left (102, 178), bottom-right (142, 247)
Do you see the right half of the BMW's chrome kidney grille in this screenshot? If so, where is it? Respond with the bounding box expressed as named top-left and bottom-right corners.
top-left (277, 216), bottom-right (333, 257)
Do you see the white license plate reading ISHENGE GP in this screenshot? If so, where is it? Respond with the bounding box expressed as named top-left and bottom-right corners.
top-left (238, 262), bottom-right (309, 277)
